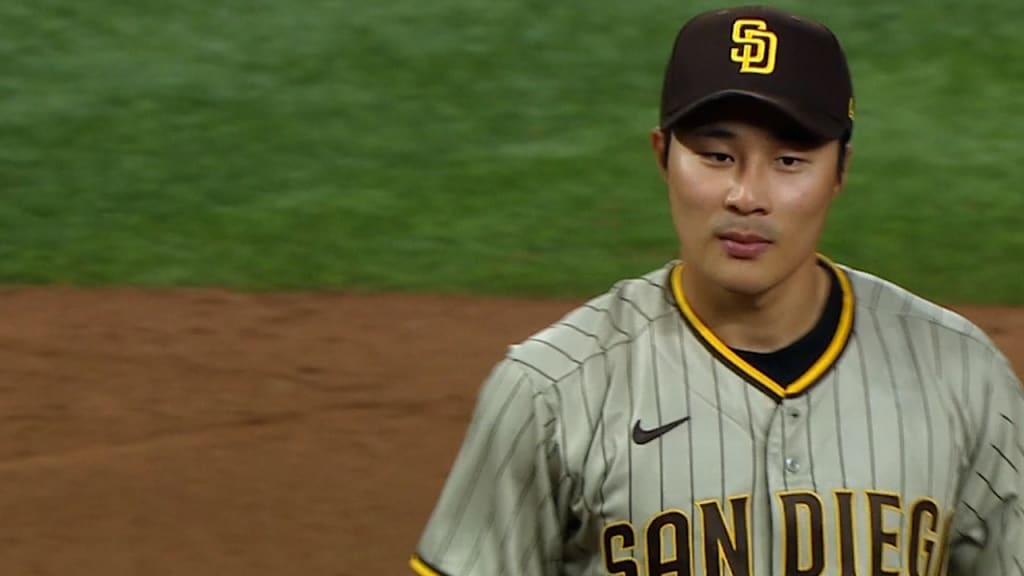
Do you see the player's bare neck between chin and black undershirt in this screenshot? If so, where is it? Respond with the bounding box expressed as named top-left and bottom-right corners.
top-left (683, 259), bottom-right (830, 353)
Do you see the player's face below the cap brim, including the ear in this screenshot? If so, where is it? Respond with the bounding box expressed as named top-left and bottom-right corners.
top-left (652, 101), bottom-right (845, 296)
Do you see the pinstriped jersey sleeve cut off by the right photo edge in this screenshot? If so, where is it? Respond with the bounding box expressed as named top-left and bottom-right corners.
top-left (949, 353), bottom-right (1024, 576)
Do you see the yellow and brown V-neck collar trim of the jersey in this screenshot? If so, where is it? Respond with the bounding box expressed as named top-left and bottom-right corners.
top-left (672, 254), bottom-right (854, 398)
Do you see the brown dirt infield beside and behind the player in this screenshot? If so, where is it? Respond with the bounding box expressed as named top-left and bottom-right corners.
top-left (0, 288), bottom-right (1024, 576)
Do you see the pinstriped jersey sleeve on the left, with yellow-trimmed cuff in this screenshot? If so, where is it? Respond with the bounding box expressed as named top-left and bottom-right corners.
top-left (411, 360), bottom-right (570, 576)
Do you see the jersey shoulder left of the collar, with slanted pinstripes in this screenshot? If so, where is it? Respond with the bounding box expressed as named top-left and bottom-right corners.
top-left (507, 262), bottom-right (676, 381)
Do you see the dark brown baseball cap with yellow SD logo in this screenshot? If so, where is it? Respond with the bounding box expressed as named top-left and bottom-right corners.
top-left (660, 6), bottom-right (854, 139)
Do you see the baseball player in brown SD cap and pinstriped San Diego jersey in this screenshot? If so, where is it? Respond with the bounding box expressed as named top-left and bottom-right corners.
top-left (411, 7), bottom-right (1024, 576)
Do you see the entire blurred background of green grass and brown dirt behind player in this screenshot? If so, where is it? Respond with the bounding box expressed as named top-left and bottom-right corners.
top-left (0, 0), bottom-right (1024, 576)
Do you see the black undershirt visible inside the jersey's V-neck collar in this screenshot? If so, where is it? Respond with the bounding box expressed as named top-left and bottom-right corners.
top-left (732, 265), bottom-right (843, 386)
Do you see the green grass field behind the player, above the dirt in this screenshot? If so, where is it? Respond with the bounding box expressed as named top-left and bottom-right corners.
top-left (0, 0), bottom-right (1024, 303)
